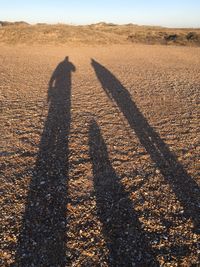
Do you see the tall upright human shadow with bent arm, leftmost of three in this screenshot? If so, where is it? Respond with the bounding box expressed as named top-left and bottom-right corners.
top-left (14, 57), bottom-right (75, 267)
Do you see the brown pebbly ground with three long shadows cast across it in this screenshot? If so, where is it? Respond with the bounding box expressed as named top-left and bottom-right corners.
top-left (0, 45), bottom-right (200, 267)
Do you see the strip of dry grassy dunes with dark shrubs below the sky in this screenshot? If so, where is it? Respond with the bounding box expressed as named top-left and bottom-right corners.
top-left (0, 22), bottom-right (200, 46)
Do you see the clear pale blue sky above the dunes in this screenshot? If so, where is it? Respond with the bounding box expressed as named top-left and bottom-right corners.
top-left (0, 0), bottom-right (200, 27)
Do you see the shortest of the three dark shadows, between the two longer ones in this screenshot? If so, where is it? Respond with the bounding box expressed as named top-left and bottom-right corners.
top-left (89, 120), bottom-right (159, 267)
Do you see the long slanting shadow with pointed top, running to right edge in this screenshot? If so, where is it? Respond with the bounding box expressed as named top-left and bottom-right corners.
top-left (91, 59), bottom-right (200, 232)
